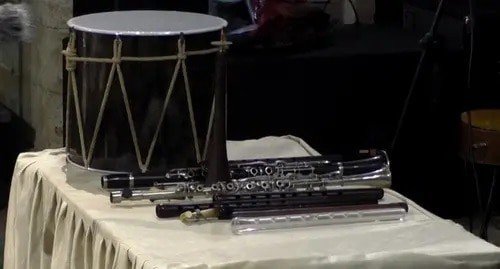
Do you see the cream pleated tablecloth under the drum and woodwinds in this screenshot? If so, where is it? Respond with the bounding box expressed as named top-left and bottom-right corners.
top-left (4, 137), bottom-right (500, 269)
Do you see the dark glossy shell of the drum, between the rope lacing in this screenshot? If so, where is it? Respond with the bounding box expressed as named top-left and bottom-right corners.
top-left (66, 28), bottom-right (220, 172)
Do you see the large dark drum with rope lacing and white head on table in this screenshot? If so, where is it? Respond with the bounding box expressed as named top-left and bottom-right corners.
top-left (65, 11), bottom-right (227, 173)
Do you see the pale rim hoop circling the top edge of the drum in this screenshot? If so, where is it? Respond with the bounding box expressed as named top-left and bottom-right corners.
top-left (66, 10), bottom-right (228, 37)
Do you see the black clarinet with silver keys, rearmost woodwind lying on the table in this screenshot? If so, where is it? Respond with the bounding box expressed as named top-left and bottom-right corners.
top-left (101, 151), bottom-right (382, 190)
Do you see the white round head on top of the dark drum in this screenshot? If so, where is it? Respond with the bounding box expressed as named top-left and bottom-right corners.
top-left (68, 10), bottom-right (227, 36)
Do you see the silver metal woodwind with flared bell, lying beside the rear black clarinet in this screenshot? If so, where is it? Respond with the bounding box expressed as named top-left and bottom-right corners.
top-left (110, 151), bottom-right (391, 203)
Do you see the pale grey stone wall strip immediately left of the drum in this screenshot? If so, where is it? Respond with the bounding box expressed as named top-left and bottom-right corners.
top-left (27, 0), bottom-right (73, 148)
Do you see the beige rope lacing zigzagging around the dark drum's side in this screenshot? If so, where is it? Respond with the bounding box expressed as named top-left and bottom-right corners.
top-left (62, 29), bottom-right (228, 172)
